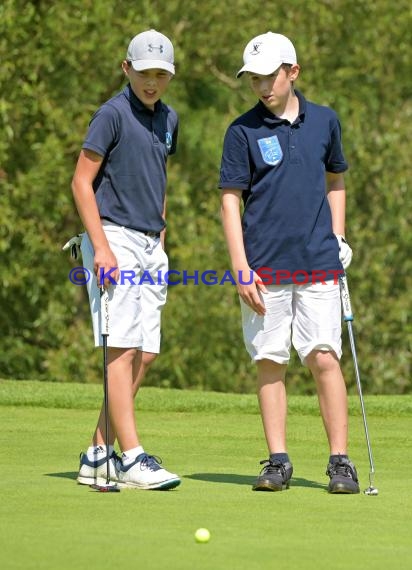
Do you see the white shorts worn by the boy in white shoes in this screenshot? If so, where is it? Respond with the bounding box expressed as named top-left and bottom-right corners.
top-left (81, 220), bottom-right (168, 353)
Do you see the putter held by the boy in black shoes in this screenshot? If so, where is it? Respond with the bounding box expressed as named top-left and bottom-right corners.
top-left (339, 274), bottom-right (379, 495)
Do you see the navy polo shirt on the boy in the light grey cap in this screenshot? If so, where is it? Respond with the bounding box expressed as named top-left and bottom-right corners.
top-left (83, 81), bottom-right (178, 232)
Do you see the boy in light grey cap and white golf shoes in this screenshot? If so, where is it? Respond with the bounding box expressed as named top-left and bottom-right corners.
top-left (72, 30), bottom-right (180, 489)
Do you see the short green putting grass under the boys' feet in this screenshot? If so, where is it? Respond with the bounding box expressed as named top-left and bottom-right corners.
top-left (0, 381), bottom-right (412, 570)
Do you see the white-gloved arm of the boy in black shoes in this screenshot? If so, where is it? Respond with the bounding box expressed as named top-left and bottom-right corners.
top-left (326, 172), bottom-right (352, 269)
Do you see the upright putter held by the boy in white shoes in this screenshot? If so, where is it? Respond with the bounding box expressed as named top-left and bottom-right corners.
top-left (90, 286), bottom-right (120, 493)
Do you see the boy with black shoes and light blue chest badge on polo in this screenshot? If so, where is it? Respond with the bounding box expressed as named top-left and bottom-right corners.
top-left (219, 32), bottom-right (359, 493)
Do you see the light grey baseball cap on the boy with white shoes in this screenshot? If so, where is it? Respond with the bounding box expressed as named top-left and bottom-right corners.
top-left (126, 30), bottom-right (175, 75)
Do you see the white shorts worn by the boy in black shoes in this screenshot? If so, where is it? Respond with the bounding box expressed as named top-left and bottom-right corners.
top-left (240, 281), bottom-right (342, 364)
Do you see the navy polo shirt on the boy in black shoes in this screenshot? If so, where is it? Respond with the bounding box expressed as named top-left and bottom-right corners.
top-left (219, 91), bottom-right (347, 284)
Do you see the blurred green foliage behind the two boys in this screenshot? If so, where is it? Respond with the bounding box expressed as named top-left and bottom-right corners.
top-left (0, 0), bottom-right (412, 394)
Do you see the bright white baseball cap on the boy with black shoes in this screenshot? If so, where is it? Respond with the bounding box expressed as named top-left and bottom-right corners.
top-left (236, 32), bottom-right (297, 77)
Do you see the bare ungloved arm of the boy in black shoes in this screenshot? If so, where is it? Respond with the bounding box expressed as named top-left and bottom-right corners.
top-left (221, 189), bottom-right (267, 315)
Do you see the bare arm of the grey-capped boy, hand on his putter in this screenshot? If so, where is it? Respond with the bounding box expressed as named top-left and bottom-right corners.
top-left (72, 149), bottom-right (119, 285)
